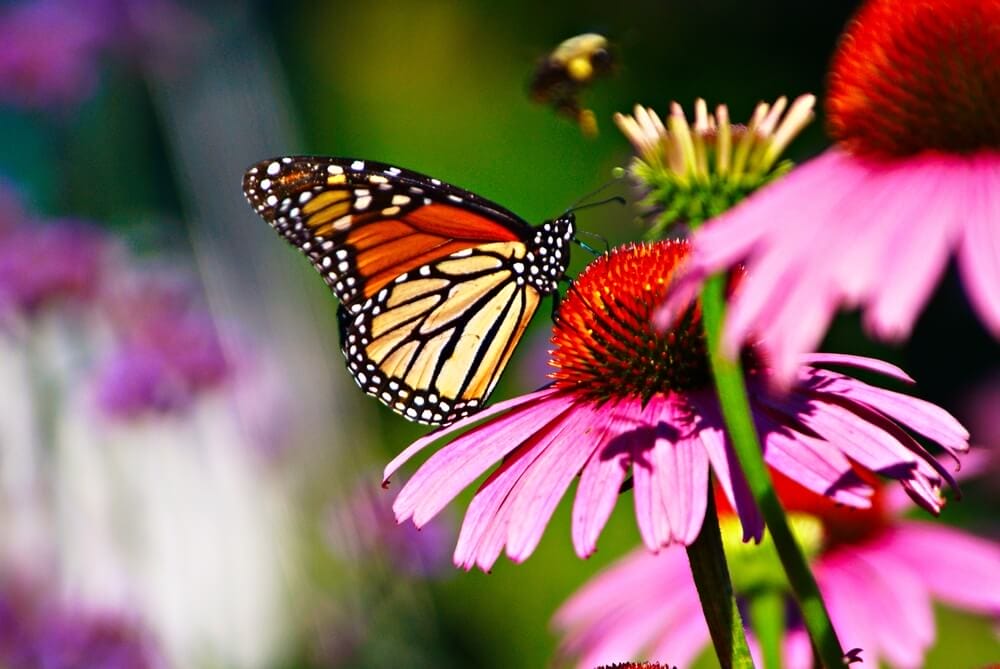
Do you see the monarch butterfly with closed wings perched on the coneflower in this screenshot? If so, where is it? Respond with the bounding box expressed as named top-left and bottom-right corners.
top-left (243, 156), bottom-right (575, 425)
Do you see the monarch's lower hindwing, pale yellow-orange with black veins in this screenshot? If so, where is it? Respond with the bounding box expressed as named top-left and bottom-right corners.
top-left (340, 237), bottom-right (542, 425)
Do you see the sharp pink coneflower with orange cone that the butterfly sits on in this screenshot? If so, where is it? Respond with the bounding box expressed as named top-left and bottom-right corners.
top-left (385, 242), bottom-right (967, 570)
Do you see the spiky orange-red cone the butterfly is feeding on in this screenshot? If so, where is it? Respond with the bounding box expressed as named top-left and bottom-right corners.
top-left (549, 241), bottom-right (724, 400)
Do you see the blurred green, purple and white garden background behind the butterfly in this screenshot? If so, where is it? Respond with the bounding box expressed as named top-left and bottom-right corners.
top-left (0, 0), bottom-right (1000, 669)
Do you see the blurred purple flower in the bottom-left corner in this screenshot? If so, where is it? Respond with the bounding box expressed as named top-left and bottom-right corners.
top-left (0, 582), bottom-right (162, 669)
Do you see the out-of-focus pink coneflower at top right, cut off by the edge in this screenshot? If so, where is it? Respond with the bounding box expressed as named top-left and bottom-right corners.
top-left (668, 0), bottom-right (1000, 382)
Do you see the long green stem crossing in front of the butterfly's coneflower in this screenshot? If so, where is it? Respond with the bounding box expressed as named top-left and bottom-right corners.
top-left (701, 274), bottom-right (844, 669)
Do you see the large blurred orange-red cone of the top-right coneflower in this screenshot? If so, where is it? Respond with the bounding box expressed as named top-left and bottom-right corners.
top-left (827, 0), bottom-right (1000, 158)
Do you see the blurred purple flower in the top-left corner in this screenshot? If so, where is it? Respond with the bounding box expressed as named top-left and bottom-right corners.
top-left (0, 0), bottom-right (104, 109)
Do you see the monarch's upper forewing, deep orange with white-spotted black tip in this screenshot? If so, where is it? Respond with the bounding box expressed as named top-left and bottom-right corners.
top-left (243, 156), bottom-right (533, 305)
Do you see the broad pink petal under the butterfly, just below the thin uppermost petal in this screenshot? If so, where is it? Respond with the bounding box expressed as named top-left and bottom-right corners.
top-left (392, 394), bottom-right (576, 527)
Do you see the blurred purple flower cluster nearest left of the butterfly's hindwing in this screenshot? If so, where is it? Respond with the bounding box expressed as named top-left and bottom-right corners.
top-left (95, 274), bottom-right (230, 418)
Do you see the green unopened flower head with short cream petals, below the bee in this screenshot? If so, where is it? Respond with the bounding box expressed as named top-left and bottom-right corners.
top-left (615, 95), bottom-right (815, 238)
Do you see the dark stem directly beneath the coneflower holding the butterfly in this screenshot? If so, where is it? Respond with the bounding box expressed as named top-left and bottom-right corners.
top-left (687, 489), bottom-right (753, 669)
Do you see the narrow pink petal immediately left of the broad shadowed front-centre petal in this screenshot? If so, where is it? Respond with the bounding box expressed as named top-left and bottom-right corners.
top-left (573, 400), bottom-right (641, 557)
